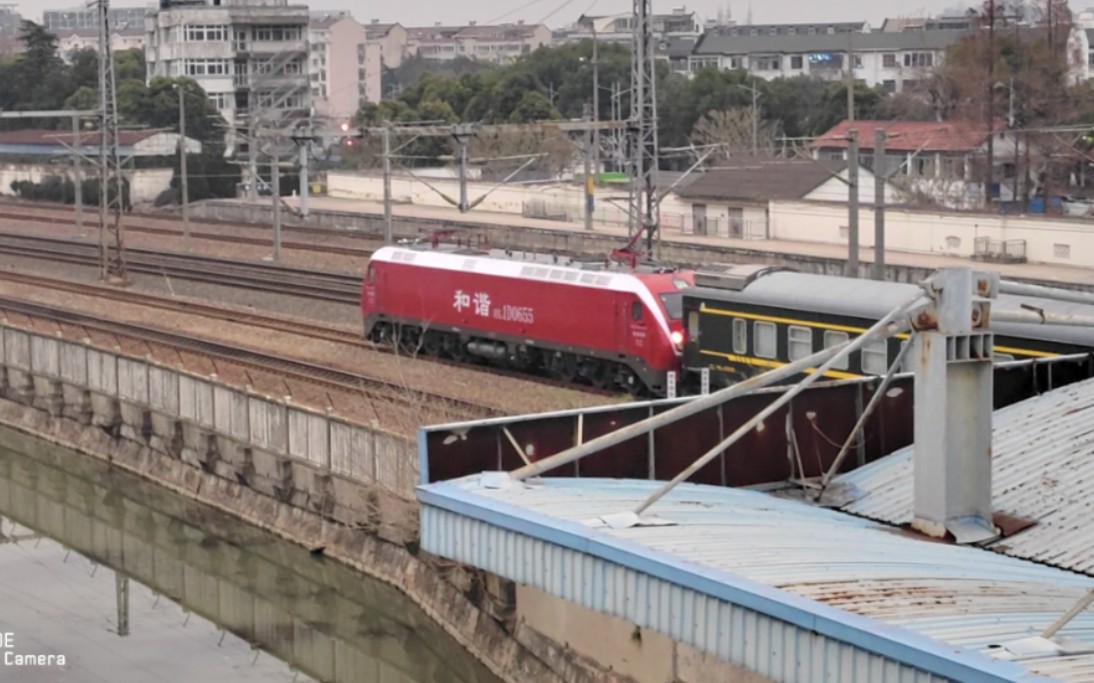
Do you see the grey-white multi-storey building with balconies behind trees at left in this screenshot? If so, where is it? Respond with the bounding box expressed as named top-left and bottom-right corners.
top-left (146, 0), bottom-right (311, 152)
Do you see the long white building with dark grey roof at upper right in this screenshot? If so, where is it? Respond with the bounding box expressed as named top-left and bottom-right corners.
top-left (688, 22), bottom-right (968, 92)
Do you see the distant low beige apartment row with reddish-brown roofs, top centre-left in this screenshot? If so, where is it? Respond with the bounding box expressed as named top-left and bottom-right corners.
top-left (407, 22), bottom-right (551, 63)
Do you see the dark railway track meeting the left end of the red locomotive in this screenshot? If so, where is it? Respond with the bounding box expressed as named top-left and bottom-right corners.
top-left (0, 233), bottom-right (361, 305)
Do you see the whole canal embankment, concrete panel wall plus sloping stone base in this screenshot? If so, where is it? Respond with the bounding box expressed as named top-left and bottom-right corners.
top-left (0, 325), bottom-right (615, 682)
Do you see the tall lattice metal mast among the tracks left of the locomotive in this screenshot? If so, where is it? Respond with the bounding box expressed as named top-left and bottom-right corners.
top-left (96, 0), bottom-right (128, 283)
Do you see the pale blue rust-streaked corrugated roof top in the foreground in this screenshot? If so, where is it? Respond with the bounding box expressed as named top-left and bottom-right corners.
top-left (423, 476), bottom-right (1094, 682)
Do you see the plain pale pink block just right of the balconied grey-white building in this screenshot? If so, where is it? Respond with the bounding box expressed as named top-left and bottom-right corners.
top-left (307, 12), bottom-right (381, 120)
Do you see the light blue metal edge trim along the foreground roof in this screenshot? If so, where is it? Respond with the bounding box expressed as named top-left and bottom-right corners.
top-left (418, 479), bottom-right (1055, 683)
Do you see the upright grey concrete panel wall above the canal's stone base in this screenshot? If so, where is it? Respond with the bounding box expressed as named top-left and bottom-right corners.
top-left (0, 325), bottom-right (419, 543)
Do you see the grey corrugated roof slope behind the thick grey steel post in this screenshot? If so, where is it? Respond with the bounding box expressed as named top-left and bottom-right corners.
top-left (834, 380), bottom-right (1094, 576)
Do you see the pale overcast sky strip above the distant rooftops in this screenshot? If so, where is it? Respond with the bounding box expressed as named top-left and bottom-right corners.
top-left (14, 0), bottom-right (976, 28)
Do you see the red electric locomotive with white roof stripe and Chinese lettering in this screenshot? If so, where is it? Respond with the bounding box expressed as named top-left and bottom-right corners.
top-left (361, 246), bottom-right (694, 395)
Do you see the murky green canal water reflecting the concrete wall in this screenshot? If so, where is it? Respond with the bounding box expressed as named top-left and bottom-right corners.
top-left (0, 428), bottom-right (497, 683)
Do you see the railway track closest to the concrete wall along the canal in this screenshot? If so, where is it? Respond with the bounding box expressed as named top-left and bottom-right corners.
top-left (0, 297), bottom-right (501, 419)
